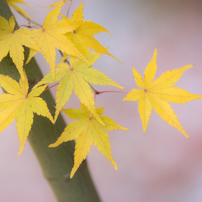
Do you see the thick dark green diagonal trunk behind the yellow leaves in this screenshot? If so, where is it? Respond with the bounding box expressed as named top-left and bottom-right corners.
top-left (0, 0), bottom-right (100, 202)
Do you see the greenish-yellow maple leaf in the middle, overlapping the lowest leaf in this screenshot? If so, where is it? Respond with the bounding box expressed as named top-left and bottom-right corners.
top-left (34, 52), bottom-right (123, 122)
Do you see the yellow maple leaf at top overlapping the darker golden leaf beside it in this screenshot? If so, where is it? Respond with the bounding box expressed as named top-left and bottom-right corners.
top-left (27, 1), bottom-right (89, 77)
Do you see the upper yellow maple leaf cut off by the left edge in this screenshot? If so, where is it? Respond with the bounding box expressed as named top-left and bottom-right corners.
top-left (0, 16), bottom-right (39, 78)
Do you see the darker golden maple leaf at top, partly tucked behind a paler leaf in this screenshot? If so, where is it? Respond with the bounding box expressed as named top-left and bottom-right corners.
top-left (63, 3), bottom-right (120, 62)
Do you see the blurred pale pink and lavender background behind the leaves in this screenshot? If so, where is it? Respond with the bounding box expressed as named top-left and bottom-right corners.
top-left (0, 0), bottom-right (202, 202)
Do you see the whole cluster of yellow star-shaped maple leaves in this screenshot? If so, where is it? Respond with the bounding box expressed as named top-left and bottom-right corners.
top-left (0, 0), bottom-right (202, 178)
